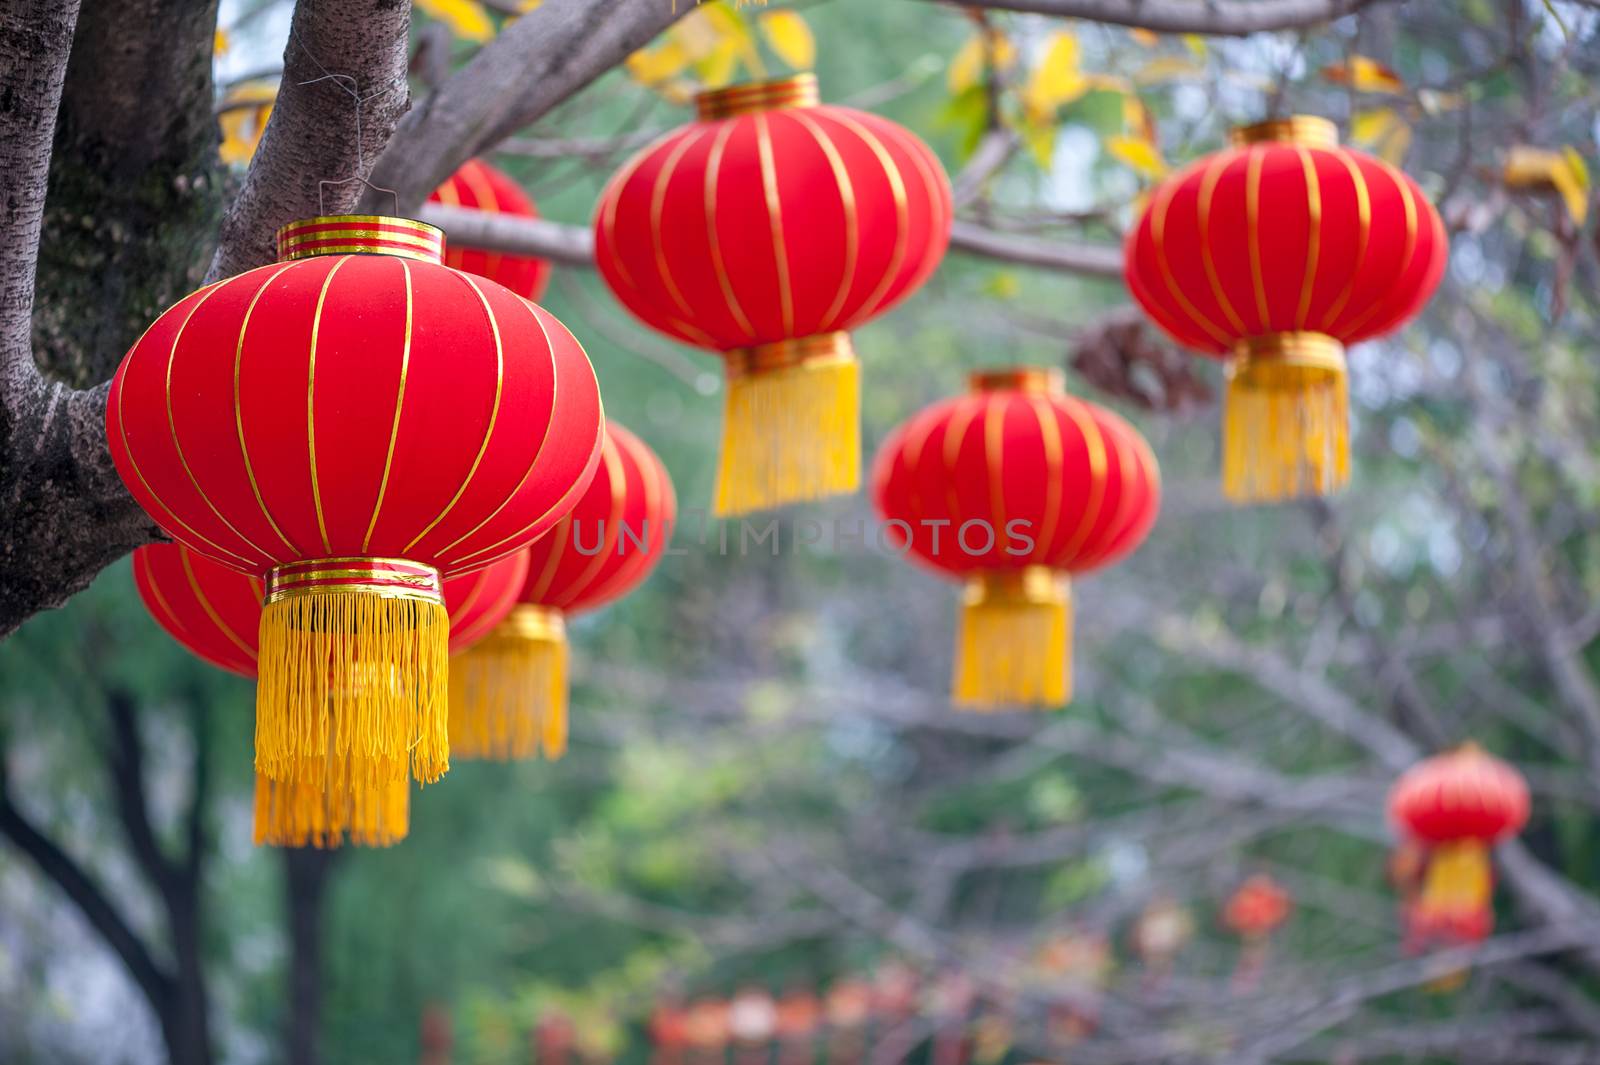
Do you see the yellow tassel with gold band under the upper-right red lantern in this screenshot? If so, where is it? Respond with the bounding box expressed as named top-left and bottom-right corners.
top-left (1222, 333), bottom-right (1350, 502)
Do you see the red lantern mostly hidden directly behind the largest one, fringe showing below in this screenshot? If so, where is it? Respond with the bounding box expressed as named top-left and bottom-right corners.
top-left (133, 544), bottom-right (528, 848)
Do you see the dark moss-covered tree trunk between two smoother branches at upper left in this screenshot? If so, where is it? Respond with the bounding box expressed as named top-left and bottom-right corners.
top-left (34, 0), bottom-right (222, 389)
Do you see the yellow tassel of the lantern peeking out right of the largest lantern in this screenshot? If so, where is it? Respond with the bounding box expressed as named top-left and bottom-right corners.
top-left (450, 604), bottom-right (566, 761)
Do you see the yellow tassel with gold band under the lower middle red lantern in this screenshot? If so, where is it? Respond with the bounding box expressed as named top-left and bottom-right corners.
top-left (950, 566), bottom-right (1072, 710)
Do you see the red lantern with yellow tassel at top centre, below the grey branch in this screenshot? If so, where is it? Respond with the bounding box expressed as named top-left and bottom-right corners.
top-left (595, 74), bottom-right (952, 515)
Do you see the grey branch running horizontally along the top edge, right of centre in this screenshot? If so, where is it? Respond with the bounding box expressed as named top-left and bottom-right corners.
top-left (928, 0), bottom-right (1374, 37)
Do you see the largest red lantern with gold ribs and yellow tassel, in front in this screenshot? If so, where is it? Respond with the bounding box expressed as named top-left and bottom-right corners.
top-left (106, 216), bottom-right (602, 785)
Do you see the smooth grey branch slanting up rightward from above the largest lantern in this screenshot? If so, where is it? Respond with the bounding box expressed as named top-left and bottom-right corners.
top-left (363, 0), bottom-right (694, 211)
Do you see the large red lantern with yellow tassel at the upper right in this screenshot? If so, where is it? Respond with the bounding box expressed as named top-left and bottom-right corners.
top-left (1125, 117), bottom-right (1448, 502)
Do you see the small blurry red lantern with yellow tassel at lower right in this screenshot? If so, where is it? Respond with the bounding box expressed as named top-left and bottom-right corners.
top-left (1389, 744), bottom-right (1528, 950)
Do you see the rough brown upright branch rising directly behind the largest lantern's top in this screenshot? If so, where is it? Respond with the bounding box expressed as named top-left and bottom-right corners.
top-left (208, 0), bottom-right (412, 280)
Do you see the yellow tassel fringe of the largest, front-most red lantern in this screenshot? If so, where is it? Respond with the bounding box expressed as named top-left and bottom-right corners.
top-left (256, 592), bottom-right (450, 792)
